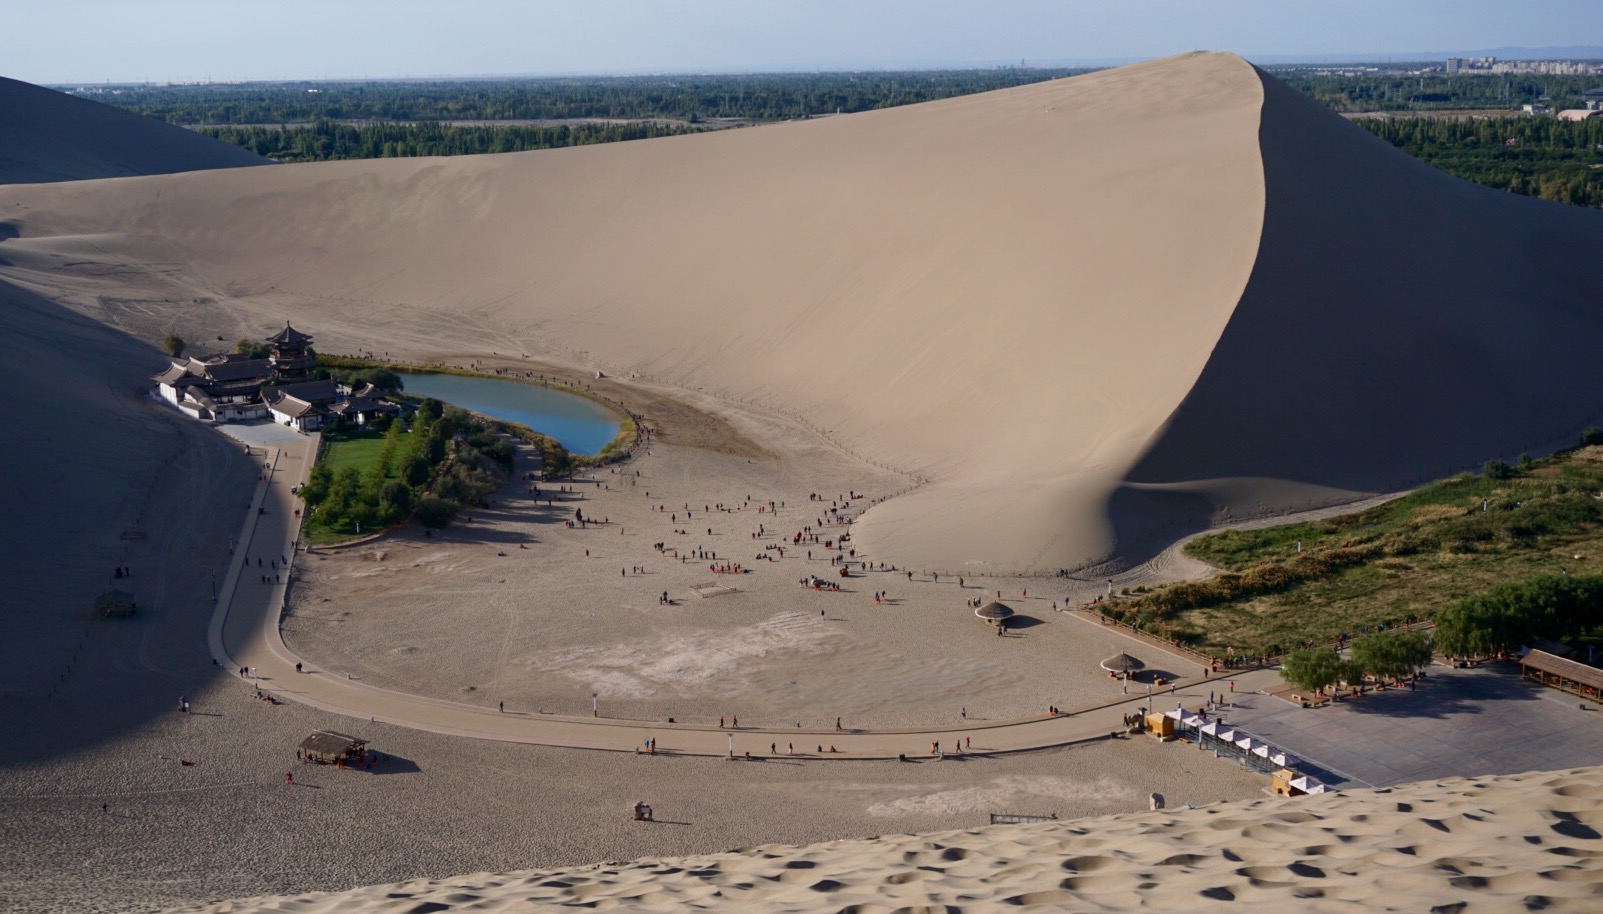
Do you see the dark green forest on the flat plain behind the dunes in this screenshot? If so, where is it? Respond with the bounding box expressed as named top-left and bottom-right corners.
top-left (78, 67), bottom-right (1603, 207)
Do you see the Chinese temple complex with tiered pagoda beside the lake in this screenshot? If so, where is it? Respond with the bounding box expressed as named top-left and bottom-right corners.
top-left (154, 322), bottom-right (401, 433)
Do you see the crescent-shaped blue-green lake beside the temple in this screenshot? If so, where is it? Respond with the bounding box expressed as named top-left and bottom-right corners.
top-left (401, 374), bottom-right (619, 455)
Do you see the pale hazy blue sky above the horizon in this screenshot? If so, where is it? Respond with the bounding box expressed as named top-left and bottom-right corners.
top-left (12, 0), bottom-right (1603, 85)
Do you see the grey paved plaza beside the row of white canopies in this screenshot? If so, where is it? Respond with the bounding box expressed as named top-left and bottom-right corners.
top-left (1225, 664), bottom-right (1603, 787)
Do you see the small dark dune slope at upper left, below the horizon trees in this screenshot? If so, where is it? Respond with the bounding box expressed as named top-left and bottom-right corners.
top-left (0, 77), bottom-right (268, 184)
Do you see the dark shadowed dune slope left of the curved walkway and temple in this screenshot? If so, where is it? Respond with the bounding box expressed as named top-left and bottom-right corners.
top-left (0, 282), bottom-right (256, 765)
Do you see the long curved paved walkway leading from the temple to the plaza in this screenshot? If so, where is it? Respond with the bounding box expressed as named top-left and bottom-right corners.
top-left (208, 428), bottom-right (1279, 760)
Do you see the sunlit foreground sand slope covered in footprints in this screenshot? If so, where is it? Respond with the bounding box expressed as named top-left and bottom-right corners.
top-left (165, 768), bottom-right (1603, 914)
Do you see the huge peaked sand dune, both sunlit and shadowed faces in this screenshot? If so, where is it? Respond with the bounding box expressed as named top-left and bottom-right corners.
top-left (3, 53), bottom-right (1603, 572)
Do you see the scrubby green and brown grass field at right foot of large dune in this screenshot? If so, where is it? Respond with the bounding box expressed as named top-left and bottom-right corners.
top-left (1109, 447), bottom-right (1603, 654)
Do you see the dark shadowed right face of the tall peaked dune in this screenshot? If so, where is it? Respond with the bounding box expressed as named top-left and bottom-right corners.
top-left (1109, 74), bottom-right (1603, 563)
